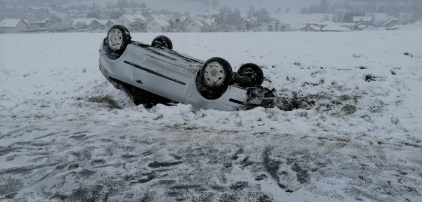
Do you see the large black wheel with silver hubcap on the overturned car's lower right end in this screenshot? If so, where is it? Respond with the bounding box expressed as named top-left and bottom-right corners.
top-left (196, 57), bottom-right (233, 100)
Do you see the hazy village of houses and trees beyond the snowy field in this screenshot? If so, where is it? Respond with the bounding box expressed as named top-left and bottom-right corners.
top-left (0, 0), bottom-right (422, 33)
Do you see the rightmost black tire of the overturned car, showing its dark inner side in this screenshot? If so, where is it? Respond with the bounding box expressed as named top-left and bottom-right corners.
top-left (237, 63), bottom-right (264, 87)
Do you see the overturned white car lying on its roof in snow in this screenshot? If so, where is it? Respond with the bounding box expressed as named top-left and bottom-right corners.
top-left (99, 25), bottom-right (275, 111)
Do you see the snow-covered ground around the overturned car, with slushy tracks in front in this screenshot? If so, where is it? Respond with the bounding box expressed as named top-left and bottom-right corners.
top-left (0, 30), bottom-right (422, 202)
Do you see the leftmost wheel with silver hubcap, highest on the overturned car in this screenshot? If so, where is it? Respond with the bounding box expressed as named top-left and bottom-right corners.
top-left (105, 25), bottom-right (131, 54)
